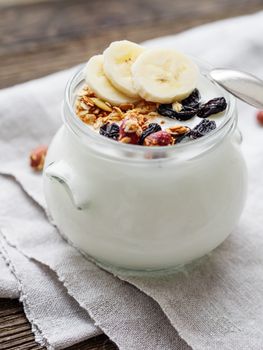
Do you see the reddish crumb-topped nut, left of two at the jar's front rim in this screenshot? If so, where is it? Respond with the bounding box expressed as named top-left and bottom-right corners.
top-left (119, 118), bottom-right (142, 144)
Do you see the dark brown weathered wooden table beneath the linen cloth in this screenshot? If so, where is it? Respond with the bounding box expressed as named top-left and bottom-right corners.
top-left (0, 0), bottom-right (263, 350)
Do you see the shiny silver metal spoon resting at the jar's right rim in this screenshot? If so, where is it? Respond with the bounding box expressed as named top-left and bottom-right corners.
top-left (209, 68), bottom-right (263, 109)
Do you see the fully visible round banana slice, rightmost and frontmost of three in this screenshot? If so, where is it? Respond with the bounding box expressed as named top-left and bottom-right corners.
top-left (132, 48), bottom-right (199, 103)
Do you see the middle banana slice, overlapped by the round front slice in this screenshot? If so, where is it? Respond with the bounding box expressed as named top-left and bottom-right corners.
top-left (103, 40), bottom-right (144, 98)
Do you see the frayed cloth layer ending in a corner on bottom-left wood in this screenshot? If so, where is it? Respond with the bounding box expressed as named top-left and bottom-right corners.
top-left (0, 233), bottom-right (102, 350)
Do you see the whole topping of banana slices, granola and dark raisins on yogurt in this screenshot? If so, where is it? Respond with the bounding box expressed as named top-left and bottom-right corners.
top-left (75, 40), bottom-right (227, 146)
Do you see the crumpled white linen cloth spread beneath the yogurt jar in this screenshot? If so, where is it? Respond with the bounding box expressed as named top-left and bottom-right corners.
top-left (0, 12), bottom-right (263, 350)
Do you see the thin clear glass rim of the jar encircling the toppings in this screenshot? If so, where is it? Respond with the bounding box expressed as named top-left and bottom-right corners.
top-left (63, 57), bottom-right (236, 159)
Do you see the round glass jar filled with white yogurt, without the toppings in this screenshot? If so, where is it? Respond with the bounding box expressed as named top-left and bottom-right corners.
top-left (44, 62), bottom-right (247, 271)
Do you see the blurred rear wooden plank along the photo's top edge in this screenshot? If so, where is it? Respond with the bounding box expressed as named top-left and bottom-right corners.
top-left (0, 0), bottom-right (263, 52)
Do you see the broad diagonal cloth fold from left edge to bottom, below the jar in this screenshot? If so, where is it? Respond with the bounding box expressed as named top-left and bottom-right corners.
top-left (0, 176), bottom-right (189, 350)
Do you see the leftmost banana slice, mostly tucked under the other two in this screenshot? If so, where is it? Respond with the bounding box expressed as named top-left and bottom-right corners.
top-left (85, 55), bottom-right (135, 106)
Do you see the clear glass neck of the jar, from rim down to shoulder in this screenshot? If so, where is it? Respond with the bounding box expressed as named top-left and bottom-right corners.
top-left (62, 62), bottom-right (237, 163)
